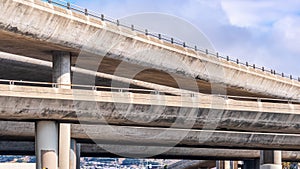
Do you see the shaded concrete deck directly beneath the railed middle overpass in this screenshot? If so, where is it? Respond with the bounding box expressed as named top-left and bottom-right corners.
top-left (0, 122), bottom-right (300, 149)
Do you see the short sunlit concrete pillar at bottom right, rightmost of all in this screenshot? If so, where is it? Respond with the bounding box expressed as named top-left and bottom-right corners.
top-left (260, 150), bottom-right (282, 169)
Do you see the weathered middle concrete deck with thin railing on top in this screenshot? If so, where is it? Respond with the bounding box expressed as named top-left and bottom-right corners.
top-left (0, 85), bottom-right (300, 133)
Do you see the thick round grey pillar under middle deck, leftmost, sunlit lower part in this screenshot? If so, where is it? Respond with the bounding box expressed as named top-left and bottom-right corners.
top-left (35, 121), bottom-right (58, 169)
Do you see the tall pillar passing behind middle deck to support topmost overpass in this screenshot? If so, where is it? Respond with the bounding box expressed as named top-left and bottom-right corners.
top-left (52, 51), bottom-right (71, 169)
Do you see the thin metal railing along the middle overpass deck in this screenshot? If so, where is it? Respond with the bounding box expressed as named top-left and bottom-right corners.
top-left (0, 79), bottom-right (300, 104)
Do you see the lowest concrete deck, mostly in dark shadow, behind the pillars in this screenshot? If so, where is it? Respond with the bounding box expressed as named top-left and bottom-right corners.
top-left (0, 141), bottom-right (300, 161)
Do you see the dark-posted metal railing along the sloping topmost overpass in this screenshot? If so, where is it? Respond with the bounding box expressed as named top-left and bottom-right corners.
top-left (42, 0), bottom-right (300, 82)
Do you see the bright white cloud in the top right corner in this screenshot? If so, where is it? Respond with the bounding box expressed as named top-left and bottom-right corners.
top-left (221, 0), bottom-right (300, 27)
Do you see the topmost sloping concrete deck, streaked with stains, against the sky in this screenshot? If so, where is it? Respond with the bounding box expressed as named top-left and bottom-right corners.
top-left (0, 0), bottom-right (300, 99)
